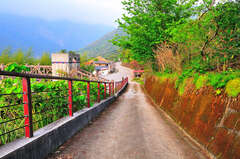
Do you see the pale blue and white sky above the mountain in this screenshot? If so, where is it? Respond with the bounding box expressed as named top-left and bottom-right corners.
top-left (0, 0), bottom-right (123, 27)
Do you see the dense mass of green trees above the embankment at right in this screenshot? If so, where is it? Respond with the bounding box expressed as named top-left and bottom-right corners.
top-left (113, 0), bottom-right (240, 70)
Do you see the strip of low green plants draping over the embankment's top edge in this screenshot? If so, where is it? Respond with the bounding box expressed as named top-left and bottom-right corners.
top-left (154, 70), bottom-right (240, 97)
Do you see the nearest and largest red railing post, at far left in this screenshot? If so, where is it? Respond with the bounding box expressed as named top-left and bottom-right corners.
top-left (22, 77), bottom-right (33, 138)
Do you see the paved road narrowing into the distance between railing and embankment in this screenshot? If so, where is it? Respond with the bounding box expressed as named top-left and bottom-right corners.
top-left (49, 63), bottom-right (209, 159)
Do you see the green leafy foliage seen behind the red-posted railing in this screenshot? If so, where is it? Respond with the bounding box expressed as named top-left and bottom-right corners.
top-left (0, 77), bottom-right (108, 145)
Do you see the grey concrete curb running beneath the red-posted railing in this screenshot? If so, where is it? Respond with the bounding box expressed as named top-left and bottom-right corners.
top-left (0, 83), bottom-right (128, 159)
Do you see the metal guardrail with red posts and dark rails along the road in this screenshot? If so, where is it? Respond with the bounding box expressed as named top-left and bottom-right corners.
top-left (0, 71), bottom-right (128, 145)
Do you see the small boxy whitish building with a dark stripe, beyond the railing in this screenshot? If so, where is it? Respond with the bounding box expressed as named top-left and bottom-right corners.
top-left (52, 53), bottom-right (80, 76)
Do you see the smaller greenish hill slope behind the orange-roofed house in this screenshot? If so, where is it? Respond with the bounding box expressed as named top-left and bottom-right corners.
top-left (80, 29), bottom-right (125, 57)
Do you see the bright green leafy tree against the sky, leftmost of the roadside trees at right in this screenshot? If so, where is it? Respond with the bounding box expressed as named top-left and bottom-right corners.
top-left (113, 0), bottom-right (195, 62)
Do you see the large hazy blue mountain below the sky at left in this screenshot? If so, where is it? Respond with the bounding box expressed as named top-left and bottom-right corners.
top-left (0, 13), bottom-right (114, 57)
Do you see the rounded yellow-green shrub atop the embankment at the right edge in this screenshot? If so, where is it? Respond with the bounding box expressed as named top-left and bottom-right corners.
top-left (226, 78), bottom-right (240, 97)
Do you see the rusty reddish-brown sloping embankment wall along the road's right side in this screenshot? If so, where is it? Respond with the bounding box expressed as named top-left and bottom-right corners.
top-left (144, 76), bottom-right (240, 159)
